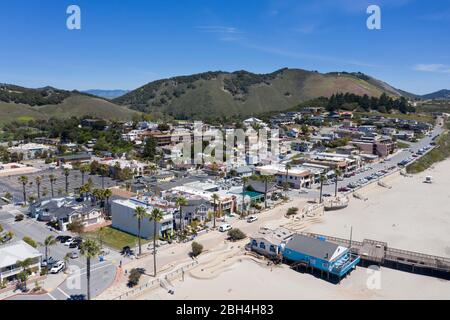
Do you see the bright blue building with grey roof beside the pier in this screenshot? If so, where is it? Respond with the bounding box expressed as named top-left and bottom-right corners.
top-left (282, 234), bottom-right (361, 279)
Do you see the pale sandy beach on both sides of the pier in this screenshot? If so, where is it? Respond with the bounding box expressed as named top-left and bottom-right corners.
top-left (136, 160), bottom-right (450, 300)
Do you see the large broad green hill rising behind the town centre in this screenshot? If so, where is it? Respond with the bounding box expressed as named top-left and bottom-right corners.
top-left (112, 69), bottom-right (412, 119)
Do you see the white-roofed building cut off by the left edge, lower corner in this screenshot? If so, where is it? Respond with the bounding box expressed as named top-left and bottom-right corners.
top-left (0, 240), bottom-right (42, 283)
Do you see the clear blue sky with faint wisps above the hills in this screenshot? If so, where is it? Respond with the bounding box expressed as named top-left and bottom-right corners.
top-left (0, 0), bottom-right (450, 93)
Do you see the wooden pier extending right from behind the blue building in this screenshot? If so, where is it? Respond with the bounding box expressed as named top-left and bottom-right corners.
top-left (301, 232), bottom-right (450, 280)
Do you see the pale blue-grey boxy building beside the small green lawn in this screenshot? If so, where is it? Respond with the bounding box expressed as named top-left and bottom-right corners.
top-left (111, 197), bottom-right (176, 239)
